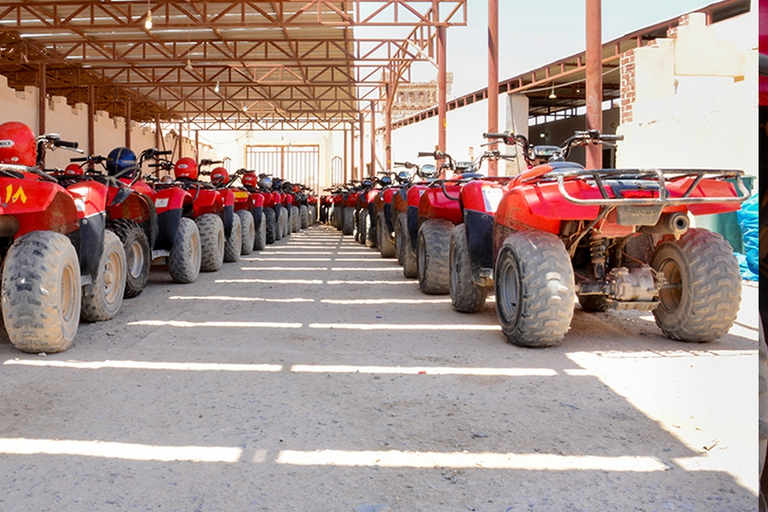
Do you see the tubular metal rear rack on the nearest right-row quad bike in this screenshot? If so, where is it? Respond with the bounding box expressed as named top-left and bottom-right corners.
top-left (542, 169), bottom-right (751, 207)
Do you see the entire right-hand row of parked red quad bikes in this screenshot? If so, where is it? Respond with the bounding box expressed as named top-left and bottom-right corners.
top-left (320, 130), bottom-right (750, 347)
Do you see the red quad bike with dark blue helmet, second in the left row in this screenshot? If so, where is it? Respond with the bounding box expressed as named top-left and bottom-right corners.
top-left (67, 147), bottom-right (158, 299)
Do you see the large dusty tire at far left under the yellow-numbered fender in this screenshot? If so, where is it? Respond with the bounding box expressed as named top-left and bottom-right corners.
top-left (0, 231), bottom-right (82, 353)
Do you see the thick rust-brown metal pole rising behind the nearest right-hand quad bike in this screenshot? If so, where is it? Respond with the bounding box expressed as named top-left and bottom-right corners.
top-left (586, 0), bottom-right (603, 169)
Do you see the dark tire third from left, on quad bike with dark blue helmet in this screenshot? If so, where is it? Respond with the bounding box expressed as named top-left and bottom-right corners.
top-left (107, 219), bottom-right (152, 299)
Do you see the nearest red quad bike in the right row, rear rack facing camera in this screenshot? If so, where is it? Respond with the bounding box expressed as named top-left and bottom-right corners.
top-left (487, 130), bottom-right (749, 347)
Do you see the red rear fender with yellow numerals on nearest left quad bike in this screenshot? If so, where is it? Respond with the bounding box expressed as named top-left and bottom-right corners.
top-left (0, 178), bottom-right (78, 237)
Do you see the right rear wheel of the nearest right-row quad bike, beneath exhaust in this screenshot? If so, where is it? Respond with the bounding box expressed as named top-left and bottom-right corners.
top-left (651, 229), bottom-right (741, 343)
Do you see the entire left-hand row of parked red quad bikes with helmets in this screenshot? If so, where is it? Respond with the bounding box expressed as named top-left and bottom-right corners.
top-left (0, 122), bottom-right (317, 353)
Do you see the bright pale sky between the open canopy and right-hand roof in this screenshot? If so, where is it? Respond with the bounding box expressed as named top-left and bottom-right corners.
top-left (413, 0), bottom-right (714, 97)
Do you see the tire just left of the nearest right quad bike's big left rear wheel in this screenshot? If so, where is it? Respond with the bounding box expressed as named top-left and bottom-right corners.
top-left (448, 224), bottom-right (490, 313)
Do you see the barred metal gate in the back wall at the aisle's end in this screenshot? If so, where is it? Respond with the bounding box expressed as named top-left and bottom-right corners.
top-left (245, 145), bottom-right (320, 191)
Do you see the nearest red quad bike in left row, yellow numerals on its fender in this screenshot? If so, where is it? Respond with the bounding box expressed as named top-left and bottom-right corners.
top-left (0, 122), bottom-right (125, 353)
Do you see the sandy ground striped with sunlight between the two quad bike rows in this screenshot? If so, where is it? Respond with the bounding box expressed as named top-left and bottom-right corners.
top-left (0, 227), bottom-right (757, 512)
